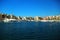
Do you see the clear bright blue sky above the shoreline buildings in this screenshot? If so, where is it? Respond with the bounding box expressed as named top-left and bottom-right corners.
top-left (0, 0), bottom-right (60, 17)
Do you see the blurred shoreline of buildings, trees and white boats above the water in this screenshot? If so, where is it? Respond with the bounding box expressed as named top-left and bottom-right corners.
top-left (0, 14), bottom-right (60, 22)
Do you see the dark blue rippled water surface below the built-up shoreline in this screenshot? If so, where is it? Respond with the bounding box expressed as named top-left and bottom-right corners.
top-left (0, 21), bottom-right (60, 40)
